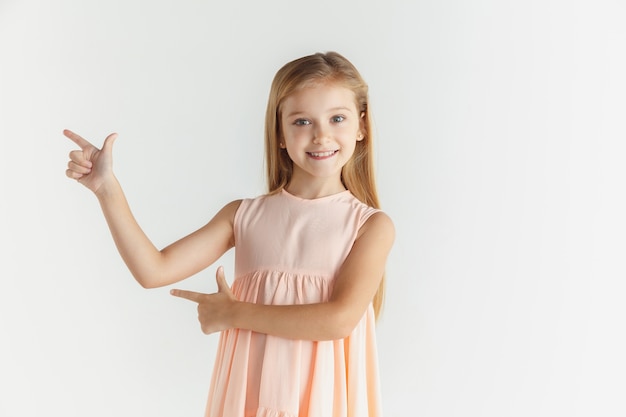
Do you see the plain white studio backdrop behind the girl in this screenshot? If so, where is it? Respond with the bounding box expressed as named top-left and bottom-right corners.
top-left (0, 0), bottom-right (626, 417)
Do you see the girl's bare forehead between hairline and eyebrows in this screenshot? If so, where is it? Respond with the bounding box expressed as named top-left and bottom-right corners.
top-left (281, 84), bottom-right (356, 114)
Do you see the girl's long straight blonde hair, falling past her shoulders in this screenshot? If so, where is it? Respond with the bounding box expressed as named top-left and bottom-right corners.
top-left (265, 52), bottom-right (385, 317)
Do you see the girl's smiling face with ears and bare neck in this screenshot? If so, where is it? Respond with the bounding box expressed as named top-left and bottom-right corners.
top-left (280, 84), bottom-right (363, 193)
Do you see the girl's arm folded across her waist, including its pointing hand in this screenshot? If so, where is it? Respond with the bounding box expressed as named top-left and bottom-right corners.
top-left (172, 212), bottom-right (395, 340)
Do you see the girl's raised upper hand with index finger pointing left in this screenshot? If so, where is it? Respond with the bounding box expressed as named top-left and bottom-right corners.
top-left (63, 130), bottom-right (117, 193)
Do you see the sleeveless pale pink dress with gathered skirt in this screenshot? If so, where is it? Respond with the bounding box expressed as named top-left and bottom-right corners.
top-left (206, 190), bottom-right (381, 417)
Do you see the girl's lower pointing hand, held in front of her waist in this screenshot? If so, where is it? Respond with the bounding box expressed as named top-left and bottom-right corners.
top-left (170, 266), bottom-right (237, 334)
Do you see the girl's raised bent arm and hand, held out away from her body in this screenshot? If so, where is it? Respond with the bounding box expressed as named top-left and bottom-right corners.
top-left (63, 130), bottom-right (240, 288)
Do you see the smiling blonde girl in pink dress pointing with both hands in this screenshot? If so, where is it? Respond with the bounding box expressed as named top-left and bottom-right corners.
top-left (64, 52), bottom-right (394, 417)
